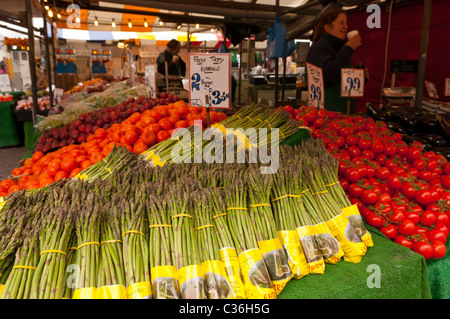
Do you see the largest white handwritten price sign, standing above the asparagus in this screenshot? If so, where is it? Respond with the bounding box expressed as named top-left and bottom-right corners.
top-left (189, 53), bottom-right (231, 109)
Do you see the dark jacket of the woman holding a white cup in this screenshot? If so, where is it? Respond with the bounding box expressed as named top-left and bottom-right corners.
top-left (306, 33), bottom-right (354, 114)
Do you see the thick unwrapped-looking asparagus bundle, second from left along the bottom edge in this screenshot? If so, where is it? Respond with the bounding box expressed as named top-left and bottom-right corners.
top-left (30, 189), bottom-right (74, 299)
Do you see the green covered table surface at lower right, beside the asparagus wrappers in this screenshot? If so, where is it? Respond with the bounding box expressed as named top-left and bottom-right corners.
top-left (278, 225), bottom-right (430, 299)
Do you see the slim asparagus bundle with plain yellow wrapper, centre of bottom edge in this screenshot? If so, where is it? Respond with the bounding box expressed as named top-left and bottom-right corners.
top-left (210, 188), bottom-right (246, 299)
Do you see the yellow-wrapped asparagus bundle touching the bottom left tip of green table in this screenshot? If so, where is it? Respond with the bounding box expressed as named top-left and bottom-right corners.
top-left (244, 166), bottom-right (293, 294)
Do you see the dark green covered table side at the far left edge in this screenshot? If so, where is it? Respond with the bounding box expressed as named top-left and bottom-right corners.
top-left (0, 102), bottom-right (21, 147)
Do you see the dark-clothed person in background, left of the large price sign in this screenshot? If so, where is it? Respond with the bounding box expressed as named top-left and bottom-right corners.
top-left (156, 39), bottom-right (186, 77)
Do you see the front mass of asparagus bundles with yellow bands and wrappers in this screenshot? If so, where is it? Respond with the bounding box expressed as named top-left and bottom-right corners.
top-left (0, 139), bottom-right (371, 299)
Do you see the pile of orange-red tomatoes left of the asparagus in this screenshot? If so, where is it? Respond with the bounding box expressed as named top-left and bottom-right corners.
top-left (0, 101), bottom-right (227, 196)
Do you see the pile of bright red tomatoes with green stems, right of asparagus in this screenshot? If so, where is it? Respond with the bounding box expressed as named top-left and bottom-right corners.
top-left (283, 106), bottom-right (450, 259)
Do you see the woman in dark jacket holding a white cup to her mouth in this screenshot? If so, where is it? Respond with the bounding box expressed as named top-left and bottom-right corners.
top-left (306, 9), bottom-right (368, 114)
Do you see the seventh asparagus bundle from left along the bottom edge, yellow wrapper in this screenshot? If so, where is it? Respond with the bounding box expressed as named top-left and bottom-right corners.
top-left (168, 184), bottom-right (207, 299)
